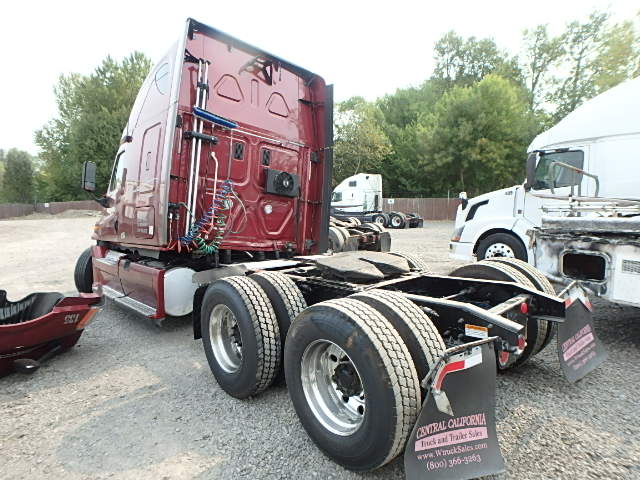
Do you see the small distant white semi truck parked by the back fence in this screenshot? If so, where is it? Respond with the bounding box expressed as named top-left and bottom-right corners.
top-left (331, 173), bottom-right (424, 228)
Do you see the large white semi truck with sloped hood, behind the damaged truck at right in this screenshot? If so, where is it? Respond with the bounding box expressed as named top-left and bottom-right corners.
top-left (449, 78), bottom-right (640, 263)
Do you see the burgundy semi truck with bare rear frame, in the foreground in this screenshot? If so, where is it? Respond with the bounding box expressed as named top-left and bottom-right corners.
top-left (75, 19), bottom-right (604, 478)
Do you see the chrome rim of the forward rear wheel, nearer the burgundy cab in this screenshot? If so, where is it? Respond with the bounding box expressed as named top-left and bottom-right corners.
top-left (209, 304), bottom-right (242, 373)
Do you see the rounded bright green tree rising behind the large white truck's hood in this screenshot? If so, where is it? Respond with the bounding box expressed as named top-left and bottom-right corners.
top-left (417, 75), bottom-right (537, 195)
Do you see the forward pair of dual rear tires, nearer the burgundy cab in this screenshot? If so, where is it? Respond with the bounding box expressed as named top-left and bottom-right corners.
top-left (200, 272), bottom-right (307, 398)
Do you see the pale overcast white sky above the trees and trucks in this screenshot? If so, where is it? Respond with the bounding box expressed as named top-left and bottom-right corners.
top-left (0, 0), bottom-right (640, 155)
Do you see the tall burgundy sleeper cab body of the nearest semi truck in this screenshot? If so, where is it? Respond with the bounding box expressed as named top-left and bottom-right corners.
top-left (93, 20), bottom-right (332, 256)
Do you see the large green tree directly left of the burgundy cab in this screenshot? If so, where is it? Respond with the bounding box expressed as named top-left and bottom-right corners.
top-left (35, 52), bottom-right (151, 201)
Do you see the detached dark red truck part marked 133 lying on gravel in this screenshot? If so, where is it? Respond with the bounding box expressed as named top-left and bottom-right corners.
top-left (0, 294), bottom-right (101, 376)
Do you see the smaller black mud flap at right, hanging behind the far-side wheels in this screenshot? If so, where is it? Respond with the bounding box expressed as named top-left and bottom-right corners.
top-left (558, 285), bottom-right (607, 382)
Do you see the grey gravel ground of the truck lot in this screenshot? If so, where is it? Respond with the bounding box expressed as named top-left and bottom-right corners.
top-left (0, 217), bottom-right (640, 480)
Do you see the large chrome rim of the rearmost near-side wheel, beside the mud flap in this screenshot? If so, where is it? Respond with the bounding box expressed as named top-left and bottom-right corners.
top-left (300, 340), bottom-right (366, 436)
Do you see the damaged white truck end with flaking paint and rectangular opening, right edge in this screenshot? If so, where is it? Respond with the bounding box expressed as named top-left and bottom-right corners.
top-left (530, 197), bottom-right (640, 307)
